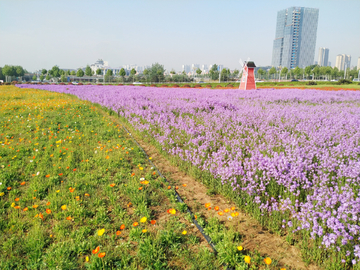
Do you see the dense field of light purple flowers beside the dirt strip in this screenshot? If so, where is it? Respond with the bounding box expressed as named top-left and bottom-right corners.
top-left (18, 85), bottom-right (360, 263)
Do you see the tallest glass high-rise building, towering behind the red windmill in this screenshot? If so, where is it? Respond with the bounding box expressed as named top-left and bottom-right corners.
top-left (271, 7), bottom-right (319, 69)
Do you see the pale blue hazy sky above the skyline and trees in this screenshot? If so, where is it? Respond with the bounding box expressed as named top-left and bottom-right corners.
top-left (0, 0), bottom-right (360, 71)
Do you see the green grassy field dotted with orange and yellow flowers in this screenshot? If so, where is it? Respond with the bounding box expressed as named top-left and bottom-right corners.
top-left (0, 86), bottom-right (289, 269)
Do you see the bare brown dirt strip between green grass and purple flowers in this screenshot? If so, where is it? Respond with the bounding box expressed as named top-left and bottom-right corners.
top-left (106, 112), bottom-right (320, 270)
